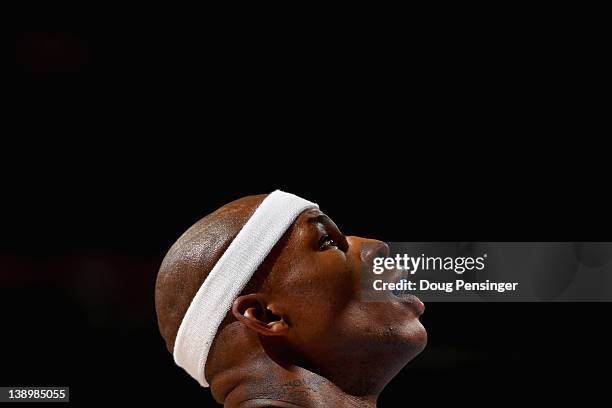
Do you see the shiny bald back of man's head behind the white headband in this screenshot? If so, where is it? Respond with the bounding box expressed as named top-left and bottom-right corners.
top-left (155, 194), bottom-right (266, 353)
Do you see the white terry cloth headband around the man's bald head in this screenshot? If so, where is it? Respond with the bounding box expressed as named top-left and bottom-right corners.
top-left (173, 190), bottom-right (319, 387)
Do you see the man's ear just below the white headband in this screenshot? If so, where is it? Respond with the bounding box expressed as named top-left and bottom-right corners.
top-left (232, 294), bottom-right (289, 336)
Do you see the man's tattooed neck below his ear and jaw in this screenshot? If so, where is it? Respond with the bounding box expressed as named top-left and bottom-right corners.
top-left (207, 325), bottom-right (378, 408)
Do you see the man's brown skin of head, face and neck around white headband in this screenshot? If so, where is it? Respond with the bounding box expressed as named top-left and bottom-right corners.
top-left (156, 195), bottom-right (427, 408)
